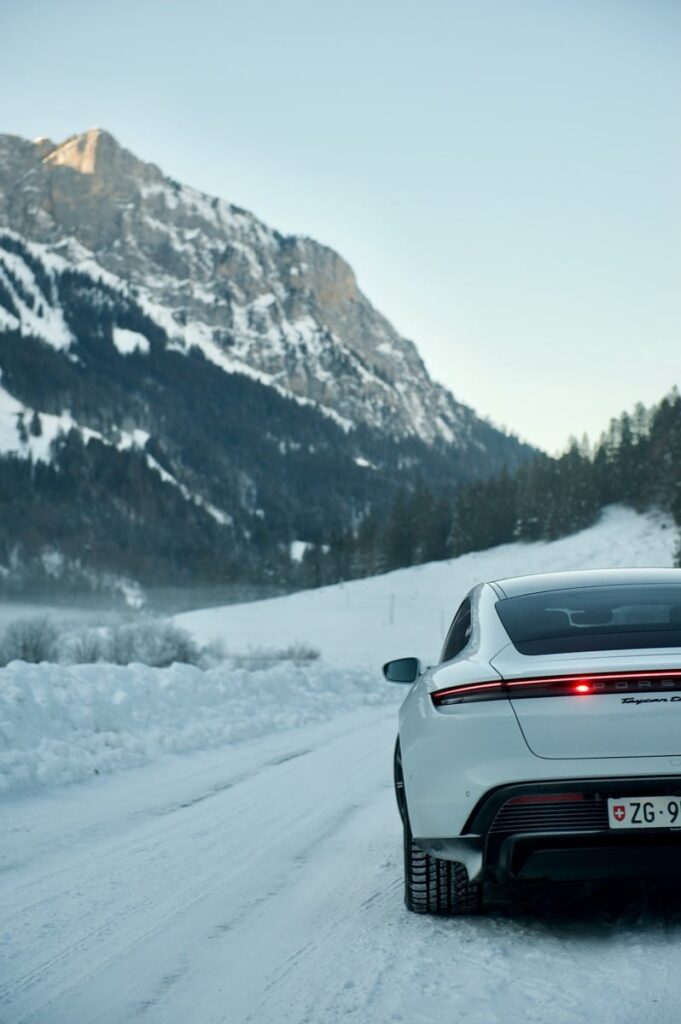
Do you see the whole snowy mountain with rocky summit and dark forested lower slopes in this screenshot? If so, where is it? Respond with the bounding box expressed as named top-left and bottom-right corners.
top-left (0, 129), bottom-right (529, 593)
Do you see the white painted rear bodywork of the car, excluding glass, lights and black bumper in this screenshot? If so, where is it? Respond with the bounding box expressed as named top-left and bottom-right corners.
top-left (399, 570), bottom-right (681, 878)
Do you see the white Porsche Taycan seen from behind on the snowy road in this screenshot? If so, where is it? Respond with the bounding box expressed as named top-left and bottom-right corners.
top-left (383, 569), bottom-right (681, 913)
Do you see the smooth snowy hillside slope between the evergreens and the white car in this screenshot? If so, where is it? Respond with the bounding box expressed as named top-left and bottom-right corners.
top-left (176, 507), bottom-right (676, 671)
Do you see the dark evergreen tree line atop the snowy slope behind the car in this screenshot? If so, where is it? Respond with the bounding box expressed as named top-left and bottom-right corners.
top-left (302, 389), bottom-right (681, 584)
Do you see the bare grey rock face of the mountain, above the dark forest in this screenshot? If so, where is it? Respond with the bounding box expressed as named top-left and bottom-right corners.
top-left (0, 129), bottom-right (497, 446)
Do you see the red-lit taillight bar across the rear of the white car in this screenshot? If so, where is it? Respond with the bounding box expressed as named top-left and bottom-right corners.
top-left (430, 669), bottom-right (681, 708)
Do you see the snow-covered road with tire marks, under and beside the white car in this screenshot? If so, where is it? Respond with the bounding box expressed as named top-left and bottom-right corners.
top-left (0, 708), bottom-right (681, 1024)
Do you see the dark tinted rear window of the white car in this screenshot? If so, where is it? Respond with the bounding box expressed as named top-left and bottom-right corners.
top-left (497, 584), bottom-right (681, 654)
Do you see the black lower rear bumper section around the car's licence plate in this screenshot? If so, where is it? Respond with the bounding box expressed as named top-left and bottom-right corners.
top-left (415, 775), bottom-right (681, 882)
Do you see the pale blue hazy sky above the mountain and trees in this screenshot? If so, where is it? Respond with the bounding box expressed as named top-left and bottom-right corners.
top-left (0, 0), bottom-right (681, 451)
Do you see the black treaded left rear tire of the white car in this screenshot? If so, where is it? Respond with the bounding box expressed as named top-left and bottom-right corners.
top-left (405, 822), bottom-right (482, 914)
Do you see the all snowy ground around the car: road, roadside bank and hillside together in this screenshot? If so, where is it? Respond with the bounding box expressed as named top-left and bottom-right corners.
top-left (0, 509), bottom-right (681, 1024)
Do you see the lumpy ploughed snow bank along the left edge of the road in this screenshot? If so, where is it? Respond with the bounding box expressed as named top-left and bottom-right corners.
top-left (0, 662), bottom-right (393, 793)
